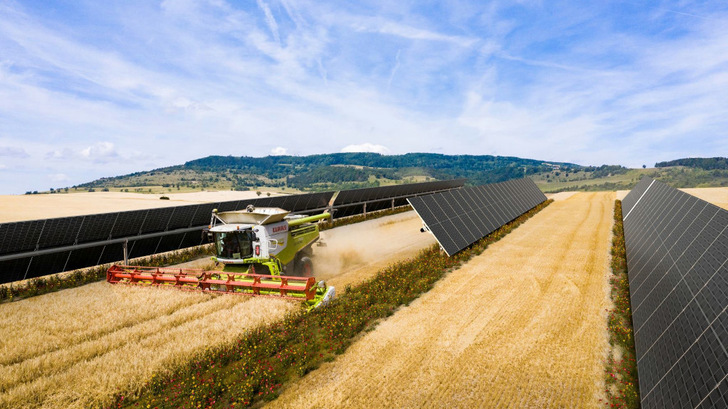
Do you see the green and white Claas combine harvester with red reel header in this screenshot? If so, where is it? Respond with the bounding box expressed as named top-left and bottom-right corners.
top-left (106, 205), bottom-right (335, 310)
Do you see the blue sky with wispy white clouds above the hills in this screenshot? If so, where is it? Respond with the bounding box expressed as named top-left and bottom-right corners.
top-left (0, 0), bottom-right (728, 194)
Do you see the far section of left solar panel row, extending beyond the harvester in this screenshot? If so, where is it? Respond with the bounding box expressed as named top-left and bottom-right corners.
top-left (333, 179), bottom-right (465, 219)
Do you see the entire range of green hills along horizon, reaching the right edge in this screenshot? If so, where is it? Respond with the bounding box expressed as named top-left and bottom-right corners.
top-left (63, 153), bottom-right (728, 194)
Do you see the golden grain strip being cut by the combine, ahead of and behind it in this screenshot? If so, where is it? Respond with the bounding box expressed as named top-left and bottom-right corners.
top-left (0, 212), bottom-right (434, 408)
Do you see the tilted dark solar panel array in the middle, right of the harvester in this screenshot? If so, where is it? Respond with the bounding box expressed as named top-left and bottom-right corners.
top-left (408, 179), bottom-right (546, 256)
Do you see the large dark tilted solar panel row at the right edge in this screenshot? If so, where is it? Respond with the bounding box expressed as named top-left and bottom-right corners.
top-left (623, 178), bottom-right (728, 409)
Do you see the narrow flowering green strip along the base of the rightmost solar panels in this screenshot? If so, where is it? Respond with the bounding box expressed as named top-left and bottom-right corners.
top-left (605, 200), bottom-right (640, 409)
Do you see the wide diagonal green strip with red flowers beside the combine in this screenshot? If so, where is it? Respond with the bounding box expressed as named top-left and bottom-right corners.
top-left (112, 200), bottom-right (552, 408)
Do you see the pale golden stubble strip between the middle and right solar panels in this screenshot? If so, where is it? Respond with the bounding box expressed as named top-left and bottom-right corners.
top-left (270, 193), bottom-right (615, 408)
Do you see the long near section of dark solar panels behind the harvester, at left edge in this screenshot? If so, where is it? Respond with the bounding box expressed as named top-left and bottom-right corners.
top-left (0, 192), bottom-right (334, 283)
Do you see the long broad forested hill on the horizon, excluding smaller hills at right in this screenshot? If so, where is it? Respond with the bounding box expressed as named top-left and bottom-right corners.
top-left (76, 153), bottom-right (584, 193)
